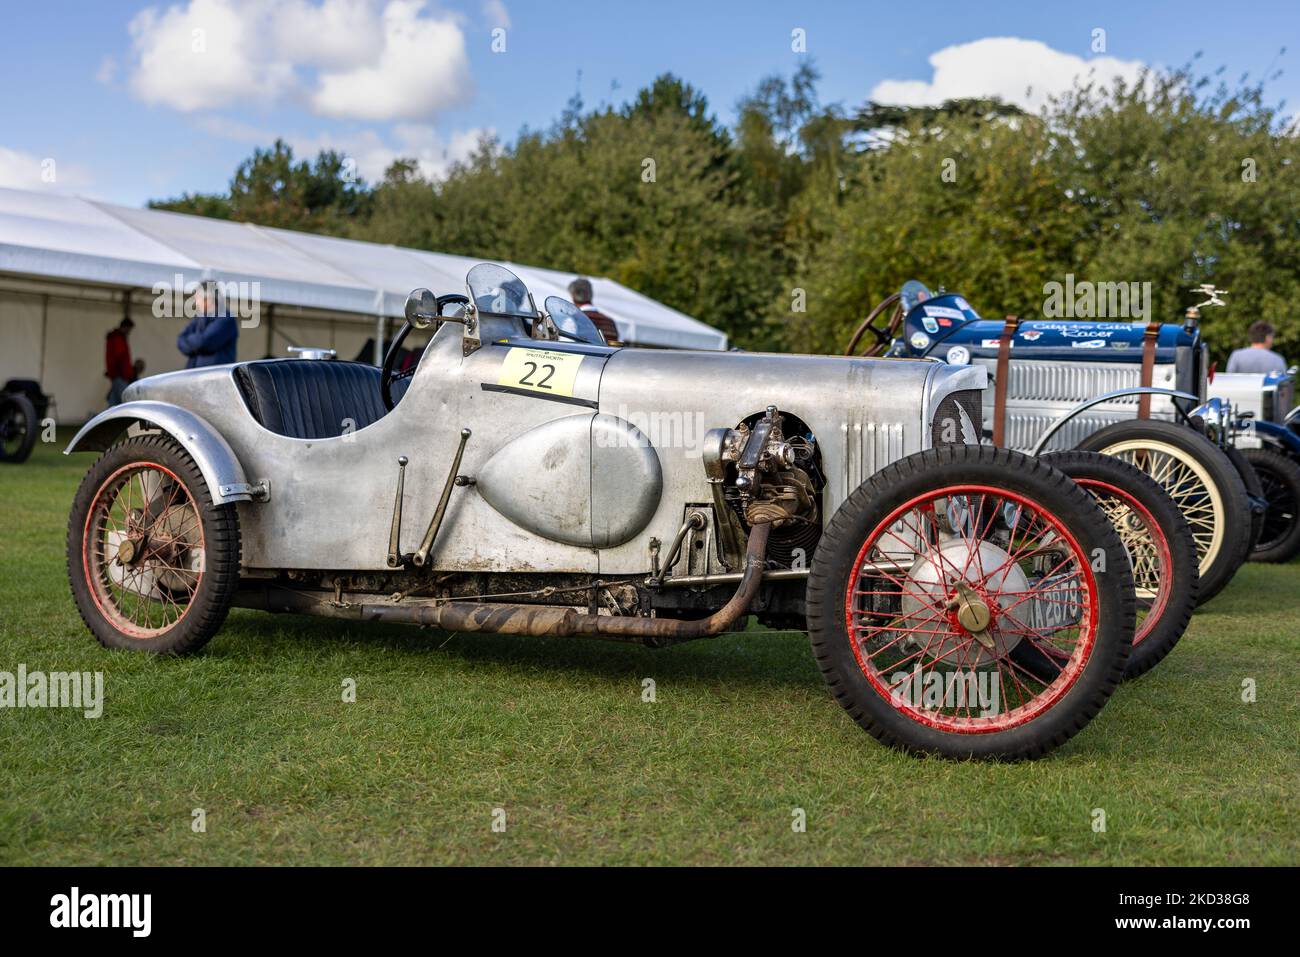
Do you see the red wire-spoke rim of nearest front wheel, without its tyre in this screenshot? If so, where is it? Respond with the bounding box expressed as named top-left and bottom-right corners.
top-left (845, 485), bottom-right (1097, 733)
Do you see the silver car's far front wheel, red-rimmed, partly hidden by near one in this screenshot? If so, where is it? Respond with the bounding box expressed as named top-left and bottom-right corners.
top-left (1041, 450), bottom-right (1200, 679)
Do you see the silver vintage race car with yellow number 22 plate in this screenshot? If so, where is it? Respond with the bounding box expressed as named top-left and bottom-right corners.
top-left (68, 264), bottom-right (1136, 758)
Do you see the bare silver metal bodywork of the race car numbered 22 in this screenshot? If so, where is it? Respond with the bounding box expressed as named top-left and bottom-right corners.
top-left (73, 319), bottom-right (987, 575)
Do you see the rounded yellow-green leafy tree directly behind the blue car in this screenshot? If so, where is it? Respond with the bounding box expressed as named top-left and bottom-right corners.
top-left (787, 106), bottom-right (1079, 352)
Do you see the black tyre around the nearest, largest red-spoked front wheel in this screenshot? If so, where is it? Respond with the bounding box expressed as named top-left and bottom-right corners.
top-left (807, 445), bottom-right (1135, 761)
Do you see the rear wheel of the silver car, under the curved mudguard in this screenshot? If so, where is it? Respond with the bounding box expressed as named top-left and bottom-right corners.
top-left (68, 434), bottom-right (239, 655)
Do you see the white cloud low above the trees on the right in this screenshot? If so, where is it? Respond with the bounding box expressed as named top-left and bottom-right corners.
top-left (870, 36), bottom-right (1143, 112)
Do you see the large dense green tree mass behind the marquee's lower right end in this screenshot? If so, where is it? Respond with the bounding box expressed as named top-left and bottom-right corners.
top-left (358, 75), bottom-right (784, 345)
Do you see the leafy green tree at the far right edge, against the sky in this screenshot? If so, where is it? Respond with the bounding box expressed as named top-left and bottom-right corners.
top-left (1049, 69), bottom-right (1300, 359)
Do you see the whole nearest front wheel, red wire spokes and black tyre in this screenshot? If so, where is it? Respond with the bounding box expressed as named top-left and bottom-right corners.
top-left (807, 446), bottom-right (1135, 759)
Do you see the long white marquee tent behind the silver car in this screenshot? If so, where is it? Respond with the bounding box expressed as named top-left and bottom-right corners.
top-left (0, 189), bottom-right (727, 423)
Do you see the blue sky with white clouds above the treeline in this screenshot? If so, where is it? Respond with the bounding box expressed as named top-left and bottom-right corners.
top-left (0, 0), bottom-right (1300, 205)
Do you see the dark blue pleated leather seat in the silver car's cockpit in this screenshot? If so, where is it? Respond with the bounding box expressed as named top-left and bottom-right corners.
top-left (234, 359), bottom-right (387, 438)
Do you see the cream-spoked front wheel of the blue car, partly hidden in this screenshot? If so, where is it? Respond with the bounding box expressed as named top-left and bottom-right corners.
top-left (1079, 419), bottom-right (1251, 605)
